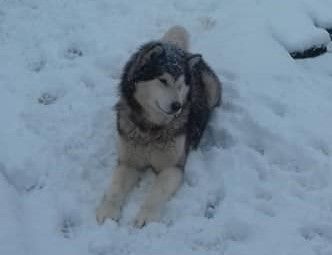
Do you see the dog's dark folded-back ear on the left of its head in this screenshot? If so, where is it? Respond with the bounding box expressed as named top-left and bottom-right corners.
top-left (127, 42), bottom-right (165, 79)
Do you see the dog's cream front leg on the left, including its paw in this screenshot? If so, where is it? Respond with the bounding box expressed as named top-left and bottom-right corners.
top-left (96, 164), bottom-right (139, 224)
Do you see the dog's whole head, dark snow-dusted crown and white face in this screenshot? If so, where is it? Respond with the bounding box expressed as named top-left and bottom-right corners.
top-left (120, 42), bottom-right (190, 125)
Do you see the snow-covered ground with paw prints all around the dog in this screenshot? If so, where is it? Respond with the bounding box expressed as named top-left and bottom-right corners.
top-left (0, 0), bottom-right (332, 255)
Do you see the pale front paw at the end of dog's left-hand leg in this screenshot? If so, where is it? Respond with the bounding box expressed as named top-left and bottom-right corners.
top-left (96, 200), bottom-right (121, 225)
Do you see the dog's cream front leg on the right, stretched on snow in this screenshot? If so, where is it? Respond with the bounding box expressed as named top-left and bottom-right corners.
top-left (134, 167), bottom-right (183, 228)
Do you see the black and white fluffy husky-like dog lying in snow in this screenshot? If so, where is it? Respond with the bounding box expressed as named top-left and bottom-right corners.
top-left (96, 26), bottom-right (222, 228)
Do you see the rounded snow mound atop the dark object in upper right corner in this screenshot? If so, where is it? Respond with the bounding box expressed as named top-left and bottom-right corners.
top-left (261, 0), bottom-right (332, 52)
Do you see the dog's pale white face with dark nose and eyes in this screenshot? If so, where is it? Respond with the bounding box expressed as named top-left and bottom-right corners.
top-left (134, 72), bottom-right (189, 124)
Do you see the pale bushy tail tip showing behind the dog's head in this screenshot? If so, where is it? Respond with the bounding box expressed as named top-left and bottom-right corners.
top-left (161, 26), bottom-right (189, 51)
